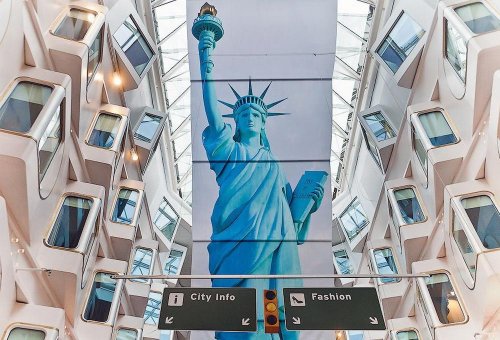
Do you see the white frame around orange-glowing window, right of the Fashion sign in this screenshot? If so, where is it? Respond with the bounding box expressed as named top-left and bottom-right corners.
top-left (416, 269), bottom-right (469, 339)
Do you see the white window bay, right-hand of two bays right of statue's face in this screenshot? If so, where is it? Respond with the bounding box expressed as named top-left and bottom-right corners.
top-left (408, 102), bottom-right (465, 216)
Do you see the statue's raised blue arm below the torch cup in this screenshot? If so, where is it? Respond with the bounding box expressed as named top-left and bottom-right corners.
top-left (198, 31), bottom-right (224, 133)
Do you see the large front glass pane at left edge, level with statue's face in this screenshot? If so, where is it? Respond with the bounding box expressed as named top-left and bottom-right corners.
top-left (0, 81), bottom-right (52, 132)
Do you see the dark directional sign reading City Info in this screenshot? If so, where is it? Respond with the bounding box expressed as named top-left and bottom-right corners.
top-left (158, 288), bottom-right (257, 332)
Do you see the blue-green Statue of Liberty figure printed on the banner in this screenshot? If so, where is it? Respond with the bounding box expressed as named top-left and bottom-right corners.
top-left (193, 4), bottom-right (324, 340)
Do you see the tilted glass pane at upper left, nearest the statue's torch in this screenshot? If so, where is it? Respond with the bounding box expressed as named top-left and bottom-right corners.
top-left (113, 16), bottom-right (153, 75)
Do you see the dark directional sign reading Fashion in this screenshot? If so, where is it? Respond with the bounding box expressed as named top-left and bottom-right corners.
top-left (283, 287), bottom-right (385, 330)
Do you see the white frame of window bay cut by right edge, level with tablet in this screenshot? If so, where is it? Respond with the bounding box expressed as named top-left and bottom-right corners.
top-left (448, 190), bottom-right (500, 289)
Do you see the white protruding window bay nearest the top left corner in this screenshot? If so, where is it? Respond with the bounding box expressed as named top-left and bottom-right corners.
top-left (45, 2), bottom-right (108, 136)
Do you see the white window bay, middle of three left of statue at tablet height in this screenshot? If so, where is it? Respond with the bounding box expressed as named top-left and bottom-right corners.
top-left (106, 180), bottom-right (144, 261)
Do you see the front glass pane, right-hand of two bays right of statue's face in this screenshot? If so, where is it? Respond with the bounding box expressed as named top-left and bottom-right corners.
top-left (418, 111), bottom-right (457, 146)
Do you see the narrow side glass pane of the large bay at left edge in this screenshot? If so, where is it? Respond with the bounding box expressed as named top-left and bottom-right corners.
top-left (38, 106), bottom-right (62, 178)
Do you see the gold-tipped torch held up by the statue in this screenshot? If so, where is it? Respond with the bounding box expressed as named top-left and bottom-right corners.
top-left (191, 2), bottom-right (224, 72)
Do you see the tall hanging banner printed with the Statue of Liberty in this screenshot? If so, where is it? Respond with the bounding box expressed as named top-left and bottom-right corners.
top-left (187, 0), bottom-right (336, 340)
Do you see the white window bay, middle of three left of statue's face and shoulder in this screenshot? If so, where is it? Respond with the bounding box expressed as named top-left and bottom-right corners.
top-left (80, 104), bottom-right (130, 206)
